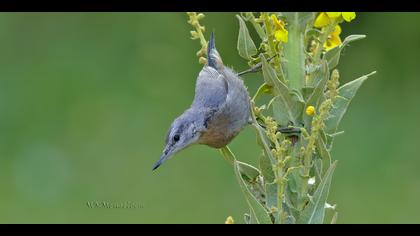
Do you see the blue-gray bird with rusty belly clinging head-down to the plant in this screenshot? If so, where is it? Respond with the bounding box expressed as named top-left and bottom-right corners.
top-left (153, 33), bottom-right (250, 170)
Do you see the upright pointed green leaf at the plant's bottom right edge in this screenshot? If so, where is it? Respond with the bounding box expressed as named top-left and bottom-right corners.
top-left (298, 161), bottom-right (337, 224)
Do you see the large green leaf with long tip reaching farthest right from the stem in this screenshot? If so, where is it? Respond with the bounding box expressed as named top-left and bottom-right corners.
top-left (325, 71), bottom-right (376, 134)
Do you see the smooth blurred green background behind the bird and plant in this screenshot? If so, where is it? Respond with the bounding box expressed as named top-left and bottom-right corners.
top-left (0, 13), bottom-right (420, 223)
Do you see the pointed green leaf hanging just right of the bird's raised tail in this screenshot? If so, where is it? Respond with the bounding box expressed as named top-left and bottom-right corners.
top-left (236, 15), bottom-right (258, 60)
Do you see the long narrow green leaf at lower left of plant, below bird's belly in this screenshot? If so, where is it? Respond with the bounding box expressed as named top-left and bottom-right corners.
top-left (234, 161), bottom-right (272, 224)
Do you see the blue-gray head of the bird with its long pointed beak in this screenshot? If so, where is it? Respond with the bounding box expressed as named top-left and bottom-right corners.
top-left (153, 111), bottom-right (200, 170)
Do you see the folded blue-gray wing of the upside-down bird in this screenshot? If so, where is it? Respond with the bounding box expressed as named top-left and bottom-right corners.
top-left (192, 66), bottom-right (228, 108)
